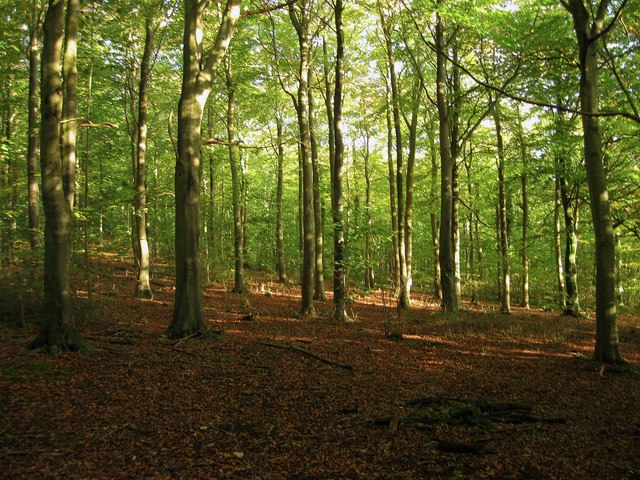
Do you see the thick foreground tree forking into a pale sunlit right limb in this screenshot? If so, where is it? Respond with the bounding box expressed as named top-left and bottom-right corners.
top-left (167, 0), bottom-right (241, 338)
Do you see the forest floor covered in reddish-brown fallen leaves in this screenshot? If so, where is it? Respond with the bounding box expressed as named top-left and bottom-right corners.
top-left (0, 259), bottom-right (640, 480)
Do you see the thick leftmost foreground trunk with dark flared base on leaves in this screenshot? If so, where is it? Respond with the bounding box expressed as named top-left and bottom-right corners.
top-left (31, 0), bottom-right (83, 354)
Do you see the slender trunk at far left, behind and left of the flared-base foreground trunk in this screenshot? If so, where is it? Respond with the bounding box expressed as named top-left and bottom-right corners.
top-left (27, 1), bottom-right (42, 251)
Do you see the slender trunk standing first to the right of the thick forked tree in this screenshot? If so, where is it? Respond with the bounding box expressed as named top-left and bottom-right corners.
top-left (226, 56), bottom-right (246, 293)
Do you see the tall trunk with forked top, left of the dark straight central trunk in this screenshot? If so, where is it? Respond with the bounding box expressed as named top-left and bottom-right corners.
top-left (289, 0), bottom-right (315, 317)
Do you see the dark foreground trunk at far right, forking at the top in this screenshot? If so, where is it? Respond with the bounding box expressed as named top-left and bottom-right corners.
top-left (566, 0), bottom-right (624, 364)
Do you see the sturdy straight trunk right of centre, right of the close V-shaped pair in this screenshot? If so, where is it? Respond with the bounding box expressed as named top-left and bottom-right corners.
top-left (436, 9), bottom-right (459, 312)
